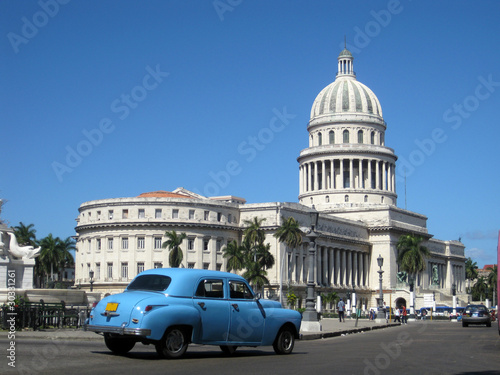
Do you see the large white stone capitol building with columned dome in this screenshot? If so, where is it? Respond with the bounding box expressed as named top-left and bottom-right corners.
top-left (75, 49), bottom-right (467, 318)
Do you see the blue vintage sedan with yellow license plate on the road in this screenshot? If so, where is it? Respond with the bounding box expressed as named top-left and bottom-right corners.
top-left (84, 268), bottom-right (302, 358)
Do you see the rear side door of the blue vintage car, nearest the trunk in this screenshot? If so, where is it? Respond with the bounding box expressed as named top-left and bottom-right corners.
top-left (193, 279), bottom-right (230, 343)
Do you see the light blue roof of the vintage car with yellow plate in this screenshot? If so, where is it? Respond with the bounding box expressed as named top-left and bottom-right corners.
top-left (131, 268), bottom-right (246, 297)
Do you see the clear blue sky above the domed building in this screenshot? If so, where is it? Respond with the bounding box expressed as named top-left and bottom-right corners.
top-left (0, 0), bottom-right (500, 267)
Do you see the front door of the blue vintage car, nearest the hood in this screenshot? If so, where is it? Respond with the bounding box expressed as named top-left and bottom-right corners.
top-left (228, 280), bottom-right (265, 345)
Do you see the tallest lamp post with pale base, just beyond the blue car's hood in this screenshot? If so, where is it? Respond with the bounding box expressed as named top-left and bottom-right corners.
top-left (301, 206), bottom-right (321, 332)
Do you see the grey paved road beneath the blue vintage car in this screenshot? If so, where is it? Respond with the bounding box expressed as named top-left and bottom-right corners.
top-left (0, 322), bottom-right (500, 375)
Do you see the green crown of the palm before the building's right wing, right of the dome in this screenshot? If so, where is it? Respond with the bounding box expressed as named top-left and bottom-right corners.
top-left (396, 234), bottom-right (430, 276)
